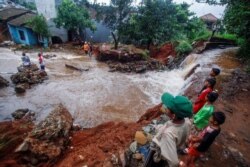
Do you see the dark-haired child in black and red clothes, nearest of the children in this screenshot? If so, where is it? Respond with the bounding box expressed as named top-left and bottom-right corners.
top-left (186, 111), bottom-right (226, 166)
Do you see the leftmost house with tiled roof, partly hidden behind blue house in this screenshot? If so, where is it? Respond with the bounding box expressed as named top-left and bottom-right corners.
top-left (0, 8), bottom-right (29, 42)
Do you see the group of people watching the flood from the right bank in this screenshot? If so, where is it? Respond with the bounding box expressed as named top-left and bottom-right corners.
top-left (144, 68), bottom-right (226, 167)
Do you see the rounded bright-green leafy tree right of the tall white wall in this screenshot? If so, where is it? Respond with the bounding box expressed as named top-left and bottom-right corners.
top-left (54, 0), bottom-right (95, 41)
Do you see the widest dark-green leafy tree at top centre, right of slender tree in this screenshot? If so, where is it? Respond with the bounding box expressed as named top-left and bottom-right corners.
top-left (122, 0), bottom-right (199, 49)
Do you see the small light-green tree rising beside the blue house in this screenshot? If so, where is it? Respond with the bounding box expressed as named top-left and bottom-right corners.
top-left (27, 15), bottom-right (50, 37)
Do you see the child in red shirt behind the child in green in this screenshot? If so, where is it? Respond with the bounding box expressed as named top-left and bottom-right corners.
top-left (193, 78), bottom-right (216, 114)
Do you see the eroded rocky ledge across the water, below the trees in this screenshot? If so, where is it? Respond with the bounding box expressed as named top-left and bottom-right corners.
top-left (96, 45), bottom-right (165, 73)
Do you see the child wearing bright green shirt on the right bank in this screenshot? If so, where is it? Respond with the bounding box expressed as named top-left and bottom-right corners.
top-left (194, 92), bottom-right (219, 130)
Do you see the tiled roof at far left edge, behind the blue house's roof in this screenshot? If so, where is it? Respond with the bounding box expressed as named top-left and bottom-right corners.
top-left (0, 8), bottom-right (29, 20)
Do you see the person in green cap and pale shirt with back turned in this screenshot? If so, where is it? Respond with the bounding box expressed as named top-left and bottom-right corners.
top-left (144, 93), bottom-right (192, 167)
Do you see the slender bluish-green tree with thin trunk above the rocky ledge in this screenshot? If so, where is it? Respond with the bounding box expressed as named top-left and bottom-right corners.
top-left (97, 0), bottom-right (133, 49)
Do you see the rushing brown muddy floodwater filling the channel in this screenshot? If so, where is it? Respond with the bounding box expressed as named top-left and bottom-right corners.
top-left (0, 48), bottom-right (238, 127)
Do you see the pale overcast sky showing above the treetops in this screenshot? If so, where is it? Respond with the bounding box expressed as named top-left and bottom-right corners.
top-left (90, 0), bottom-right (225, 18)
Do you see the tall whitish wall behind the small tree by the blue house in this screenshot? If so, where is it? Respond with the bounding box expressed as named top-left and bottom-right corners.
top-left (35, 0), bottom-right (68, 42)
